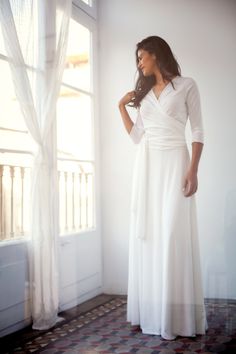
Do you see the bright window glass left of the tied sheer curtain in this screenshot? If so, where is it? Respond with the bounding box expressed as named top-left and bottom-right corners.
top-left (0, 37), bottom-right (35, 240)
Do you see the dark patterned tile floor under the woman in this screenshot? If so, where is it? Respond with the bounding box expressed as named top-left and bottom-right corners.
top-left (1, 297), bottom-right (236, 354)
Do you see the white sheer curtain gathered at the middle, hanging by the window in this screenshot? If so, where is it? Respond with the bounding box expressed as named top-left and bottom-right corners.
top-left (0, 0), bottom-right (72, 329)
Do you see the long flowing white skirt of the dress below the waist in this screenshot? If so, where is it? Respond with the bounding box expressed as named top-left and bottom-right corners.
top-left (127, 143), bottom-right (207, 340)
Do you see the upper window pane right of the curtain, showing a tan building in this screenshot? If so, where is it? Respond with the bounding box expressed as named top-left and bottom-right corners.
top-left (62, 19), bottom-right (91, 91)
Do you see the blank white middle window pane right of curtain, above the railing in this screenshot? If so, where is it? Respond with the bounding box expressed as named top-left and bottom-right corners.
top-left (57, 86), bottom-right (93, 160)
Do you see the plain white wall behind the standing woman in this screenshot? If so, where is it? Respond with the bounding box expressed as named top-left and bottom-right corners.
top-left (98, 0), bottom-right (236, 299)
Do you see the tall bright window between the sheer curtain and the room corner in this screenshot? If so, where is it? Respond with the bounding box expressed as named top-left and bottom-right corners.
top-left (57, 18), bottom-right (95, 234)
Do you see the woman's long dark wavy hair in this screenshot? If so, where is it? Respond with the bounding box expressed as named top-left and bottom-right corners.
top-left (130, 36), bottom-right (181, 108)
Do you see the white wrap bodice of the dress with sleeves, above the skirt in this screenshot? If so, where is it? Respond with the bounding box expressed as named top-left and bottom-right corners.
top-left (130, 76), bottom-right (204, 147)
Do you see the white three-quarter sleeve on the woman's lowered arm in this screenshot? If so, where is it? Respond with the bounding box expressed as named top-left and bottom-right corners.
top-left (186, 79), bottom-right (204, 143)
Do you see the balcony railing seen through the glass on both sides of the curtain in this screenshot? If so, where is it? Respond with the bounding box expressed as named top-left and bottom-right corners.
top-left (0, 152), bottom-right (95, 241)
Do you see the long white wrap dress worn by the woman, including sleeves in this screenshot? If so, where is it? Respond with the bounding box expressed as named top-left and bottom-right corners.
top-left (127, 76), bottom-right (207, 340)
